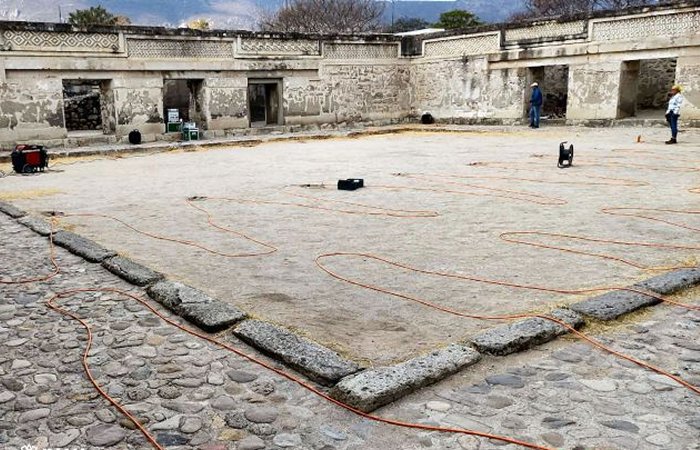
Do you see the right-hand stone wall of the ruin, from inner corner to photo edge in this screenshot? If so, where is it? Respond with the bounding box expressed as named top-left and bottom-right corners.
top-left (411, 2), bottom-right (700, 123)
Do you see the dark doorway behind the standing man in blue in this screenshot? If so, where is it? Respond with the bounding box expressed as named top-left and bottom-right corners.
top-left (525, 65), bottom-right (569, 120)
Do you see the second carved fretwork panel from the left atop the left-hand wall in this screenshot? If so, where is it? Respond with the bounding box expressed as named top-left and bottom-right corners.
top-left (127, 39), bottom-right (233, 59)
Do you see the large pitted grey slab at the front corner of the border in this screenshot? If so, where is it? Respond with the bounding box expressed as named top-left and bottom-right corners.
top-left (330, 344), bottom-right (481, 412)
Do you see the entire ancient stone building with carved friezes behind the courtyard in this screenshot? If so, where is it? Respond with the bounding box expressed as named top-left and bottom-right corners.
top-left (0, 0), bottom-right (700, 148)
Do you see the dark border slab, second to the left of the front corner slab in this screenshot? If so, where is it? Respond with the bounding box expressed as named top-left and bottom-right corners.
top-left (147, 280), bottom-right (247, 332)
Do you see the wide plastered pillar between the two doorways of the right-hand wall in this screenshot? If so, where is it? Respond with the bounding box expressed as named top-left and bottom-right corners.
top-left (566, 61), bottom-right (622, 121)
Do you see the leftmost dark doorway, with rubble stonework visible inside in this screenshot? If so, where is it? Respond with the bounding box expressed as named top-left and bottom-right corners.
top-left (63, 80), bottom-right (106, 134)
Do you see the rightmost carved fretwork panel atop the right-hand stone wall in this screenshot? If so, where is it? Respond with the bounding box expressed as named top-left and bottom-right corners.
top-left (592, 11), bottom-right (700, 41)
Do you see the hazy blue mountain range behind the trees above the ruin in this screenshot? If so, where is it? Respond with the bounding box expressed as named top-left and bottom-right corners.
top-left (0, 0), bottom-right (524, 29)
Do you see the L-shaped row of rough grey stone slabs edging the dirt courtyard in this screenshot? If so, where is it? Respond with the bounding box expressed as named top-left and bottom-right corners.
top-left (0, 201), bottom-right (700, 412)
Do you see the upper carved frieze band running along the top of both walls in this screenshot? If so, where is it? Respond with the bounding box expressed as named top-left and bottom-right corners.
top-left (0, 0), bottom-right (700, 62)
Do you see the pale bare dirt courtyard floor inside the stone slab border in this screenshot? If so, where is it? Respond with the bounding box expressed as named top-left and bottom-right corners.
top-left (0, 128), bottom-right (700, 365)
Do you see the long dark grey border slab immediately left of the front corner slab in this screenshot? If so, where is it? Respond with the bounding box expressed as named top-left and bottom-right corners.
top-left (233, 320), bottom-right (360, 385)
